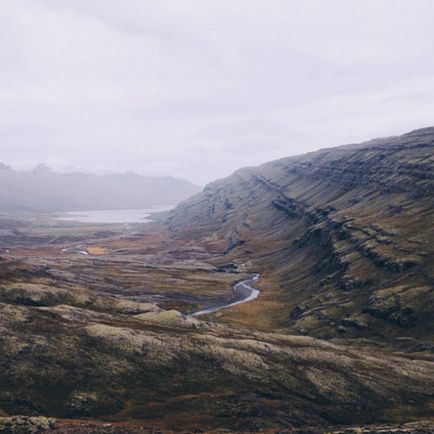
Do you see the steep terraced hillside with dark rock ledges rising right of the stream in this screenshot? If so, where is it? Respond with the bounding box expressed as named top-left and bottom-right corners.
top-left (167, 128), bottom-right (434, 349)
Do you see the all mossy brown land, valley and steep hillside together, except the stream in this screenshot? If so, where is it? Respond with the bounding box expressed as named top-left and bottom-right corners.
top-left (0, 128), bottom-right (434, 434)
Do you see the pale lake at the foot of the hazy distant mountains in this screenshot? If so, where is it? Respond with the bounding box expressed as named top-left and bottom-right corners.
top-left (56, 206), bottom-right (174, 223)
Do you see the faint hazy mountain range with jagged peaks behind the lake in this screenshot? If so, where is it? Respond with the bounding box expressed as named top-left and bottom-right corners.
top-left (0, 163), bottom-right (201, 212)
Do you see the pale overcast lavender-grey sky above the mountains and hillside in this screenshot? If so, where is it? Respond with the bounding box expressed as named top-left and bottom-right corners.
top-left (0, 0), bottom-right (434, 184)
